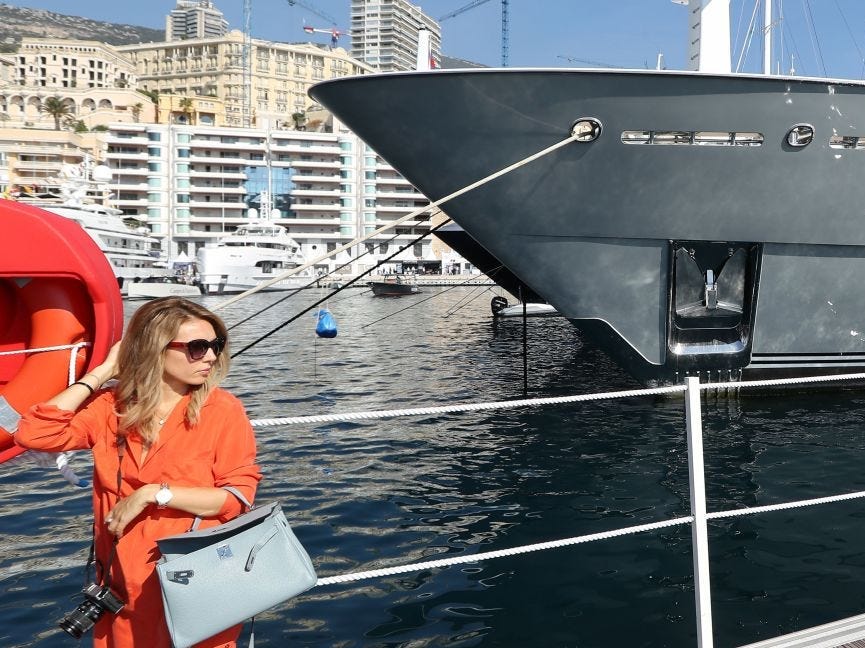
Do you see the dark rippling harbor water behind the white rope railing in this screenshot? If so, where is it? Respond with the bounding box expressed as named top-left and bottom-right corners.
top-left (0, 288), bottom-right (865, 648)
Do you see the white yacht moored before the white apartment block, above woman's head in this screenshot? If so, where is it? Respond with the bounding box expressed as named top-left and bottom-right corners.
top-left (196, 221), bottom-right (314, 295)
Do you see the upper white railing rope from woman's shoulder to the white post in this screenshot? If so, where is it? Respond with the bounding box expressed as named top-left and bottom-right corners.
top-left (251, 385), bottom-right (685, 427)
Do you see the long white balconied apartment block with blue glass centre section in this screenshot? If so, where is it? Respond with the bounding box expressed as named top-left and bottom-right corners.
top-left (104, 124), bottom-right (441, 273)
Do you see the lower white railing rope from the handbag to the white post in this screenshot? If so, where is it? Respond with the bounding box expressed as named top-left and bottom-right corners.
top-left (316, 516), bottom-right (694, 585)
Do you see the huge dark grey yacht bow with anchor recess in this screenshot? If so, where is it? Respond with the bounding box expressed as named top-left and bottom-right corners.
top-left (310, 0), bottom-right (865, 384)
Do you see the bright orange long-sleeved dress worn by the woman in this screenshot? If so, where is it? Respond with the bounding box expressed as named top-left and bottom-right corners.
top-left (15, 389), bottom-right (261, 648)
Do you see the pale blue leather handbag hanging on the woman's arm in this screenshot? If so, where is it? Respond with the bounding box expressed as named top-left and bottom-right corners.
top-left (156, 487), bottom-right (318, 648)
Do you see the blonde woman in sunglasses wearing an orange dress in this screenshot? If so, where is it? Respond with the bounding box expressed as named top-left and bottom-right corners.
top-left (15, 297), bottom-right (261, 648)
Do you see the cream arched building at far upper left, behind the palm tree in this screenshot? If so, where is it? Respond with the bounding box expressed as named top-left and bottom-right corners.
top-left (0, 38), bottom-right (156, 130)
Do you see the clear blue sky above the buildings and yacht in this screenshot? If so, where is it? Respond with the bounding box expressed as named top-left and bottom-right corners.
top-left (4, 0), bottom-right (865, 79)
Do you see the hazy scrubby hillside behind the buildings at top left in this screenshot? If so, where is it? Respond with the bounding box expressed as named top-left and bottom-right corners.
top-left (0, 3), bottom-right (165, 52)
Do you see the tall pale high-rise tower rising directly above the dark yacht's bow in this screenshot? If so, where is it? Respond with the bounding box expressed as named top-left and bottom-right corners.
top-left (351, 0), bottom-right (441, 72)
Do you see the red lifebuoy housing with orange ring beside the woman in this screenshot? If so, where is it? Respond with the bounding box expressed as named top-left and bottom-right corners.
top-left (0, 200), bottom-right (123, 463)
